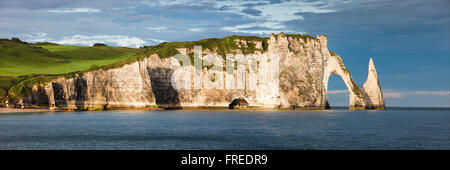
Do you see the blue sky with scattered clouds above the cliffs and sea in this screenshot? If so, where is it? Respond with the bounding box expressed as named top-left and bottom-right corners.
top-left (0, 0), bottom-right (450, 107)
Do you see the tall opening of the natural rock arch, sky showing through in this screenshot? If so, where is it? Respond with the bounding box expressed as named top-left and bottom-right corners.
top-left (327, 75), bottom-right (349, 109)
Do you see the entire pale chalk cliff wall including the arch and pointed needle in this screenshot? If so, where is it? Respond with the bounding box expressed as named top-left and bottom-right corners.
top-left (17, 33), bottom-right (384, 110)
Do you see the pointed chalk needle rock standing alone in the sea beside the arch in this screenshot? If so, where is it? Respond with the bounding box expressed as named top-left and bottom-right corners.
top-left (362, 58), bottom-right (386, 110)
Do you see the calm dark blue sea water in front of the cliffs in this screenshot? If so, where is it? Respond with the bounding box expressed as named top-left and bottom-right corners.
top-left (0, 108), bottom-right (450, 150)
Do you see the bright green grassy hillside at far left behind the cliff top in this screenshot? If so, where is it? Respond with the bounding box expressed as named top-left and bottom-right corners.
top-left (0, 41), bottom-right (138, 77)
